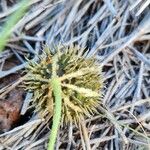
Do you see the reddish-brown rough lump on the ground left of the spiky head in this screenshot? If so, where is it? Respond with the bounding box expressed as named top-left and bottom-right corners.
top-left (0, 83), bottom-right (24, 132)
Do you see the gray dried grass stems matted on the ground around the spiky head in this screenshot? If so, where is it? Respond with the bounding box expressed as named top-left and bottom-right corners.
top-left (0, 0), bottom-right (150, 150)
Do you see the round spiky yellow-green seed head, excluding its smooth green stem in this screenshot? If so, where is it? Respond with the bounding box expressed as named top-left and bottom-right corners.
top-left (24, 47), bottom-right (103, 124)
